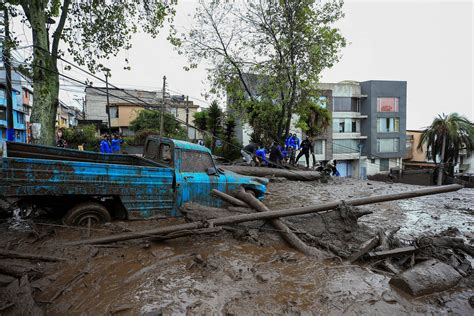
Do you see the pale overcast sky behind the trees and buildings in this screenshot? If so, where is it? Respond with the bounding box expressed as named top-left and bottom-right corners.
top-left (14, 0), bottom-right (474, 129)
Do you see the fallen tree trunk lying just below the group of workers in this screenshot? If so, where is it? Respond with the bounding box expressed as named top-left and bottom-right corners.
top-left (220, 165), bottom-right (321, 181)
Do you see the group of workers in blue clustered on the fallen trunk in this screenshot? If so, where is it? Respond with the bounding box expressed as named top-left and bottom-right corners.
top-left (240, 134), bottom-right (338, 175)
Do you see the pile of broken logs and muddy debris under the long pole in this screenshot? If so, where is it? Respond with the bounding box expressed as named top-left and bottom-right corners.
top-left (183, 186), bottom-right (474, 296)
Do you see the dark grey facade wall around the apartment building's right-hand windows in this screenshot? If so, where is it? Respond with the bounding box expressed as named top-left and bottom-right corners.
top-left (360, 80), bottom-right (407, 158)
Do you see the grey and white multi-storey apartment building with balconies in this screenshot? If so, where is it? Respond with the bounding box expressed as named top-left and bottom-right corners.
top-left (231, 80), bottom-right (407, 178)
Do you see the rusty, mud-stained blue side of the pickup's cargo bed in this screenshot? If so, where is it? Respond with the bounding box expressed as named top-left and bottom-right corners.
top-left (0, 143), bottom-right (175, 218)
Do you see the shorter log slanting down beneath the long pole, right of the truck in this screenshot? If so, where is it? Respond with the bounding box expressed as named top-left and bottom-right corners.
top-left (236, 189), bottom-right (328, 259)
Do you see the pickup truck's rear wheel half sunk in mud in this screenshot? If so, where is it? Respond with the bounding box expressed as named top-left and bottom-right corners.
top-left (63, 202), bottom-right (112, 226)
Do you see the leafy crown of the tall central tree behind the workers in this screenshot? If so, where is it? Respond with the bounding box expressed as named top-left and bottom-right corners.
top-left (174, 0), bottom-right (346, 143)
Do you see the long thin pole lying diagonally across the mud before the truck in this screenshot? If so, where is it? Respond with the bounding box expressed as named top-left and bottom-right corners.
top-left (66, 184), bottom-right (462, 245)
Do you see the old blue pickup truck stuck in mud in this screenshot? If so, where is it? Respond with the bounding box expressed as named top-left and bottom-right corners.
top-left (0, 136), bottom-right (268, 225)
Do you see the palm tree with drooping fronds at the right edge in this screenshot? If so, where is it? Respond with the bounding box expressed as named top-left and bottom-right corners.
top-left (418, 113), bottom-right (474, 185)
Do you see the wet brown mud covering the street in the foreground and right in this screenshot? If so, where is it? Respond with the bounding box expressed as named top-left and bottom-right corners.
top-left (0, 179), bottom-right (474, 315)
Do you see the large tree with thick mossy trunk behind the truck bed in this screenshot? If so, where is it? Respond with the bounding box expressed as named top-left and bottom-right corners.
top-left (5, 0), bottom-right (176, 144)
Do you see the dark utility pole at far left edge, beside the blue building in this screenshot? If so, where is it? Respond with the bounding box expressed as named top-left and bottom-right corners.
top-left (3, 6), bottom-right (15, 142)
